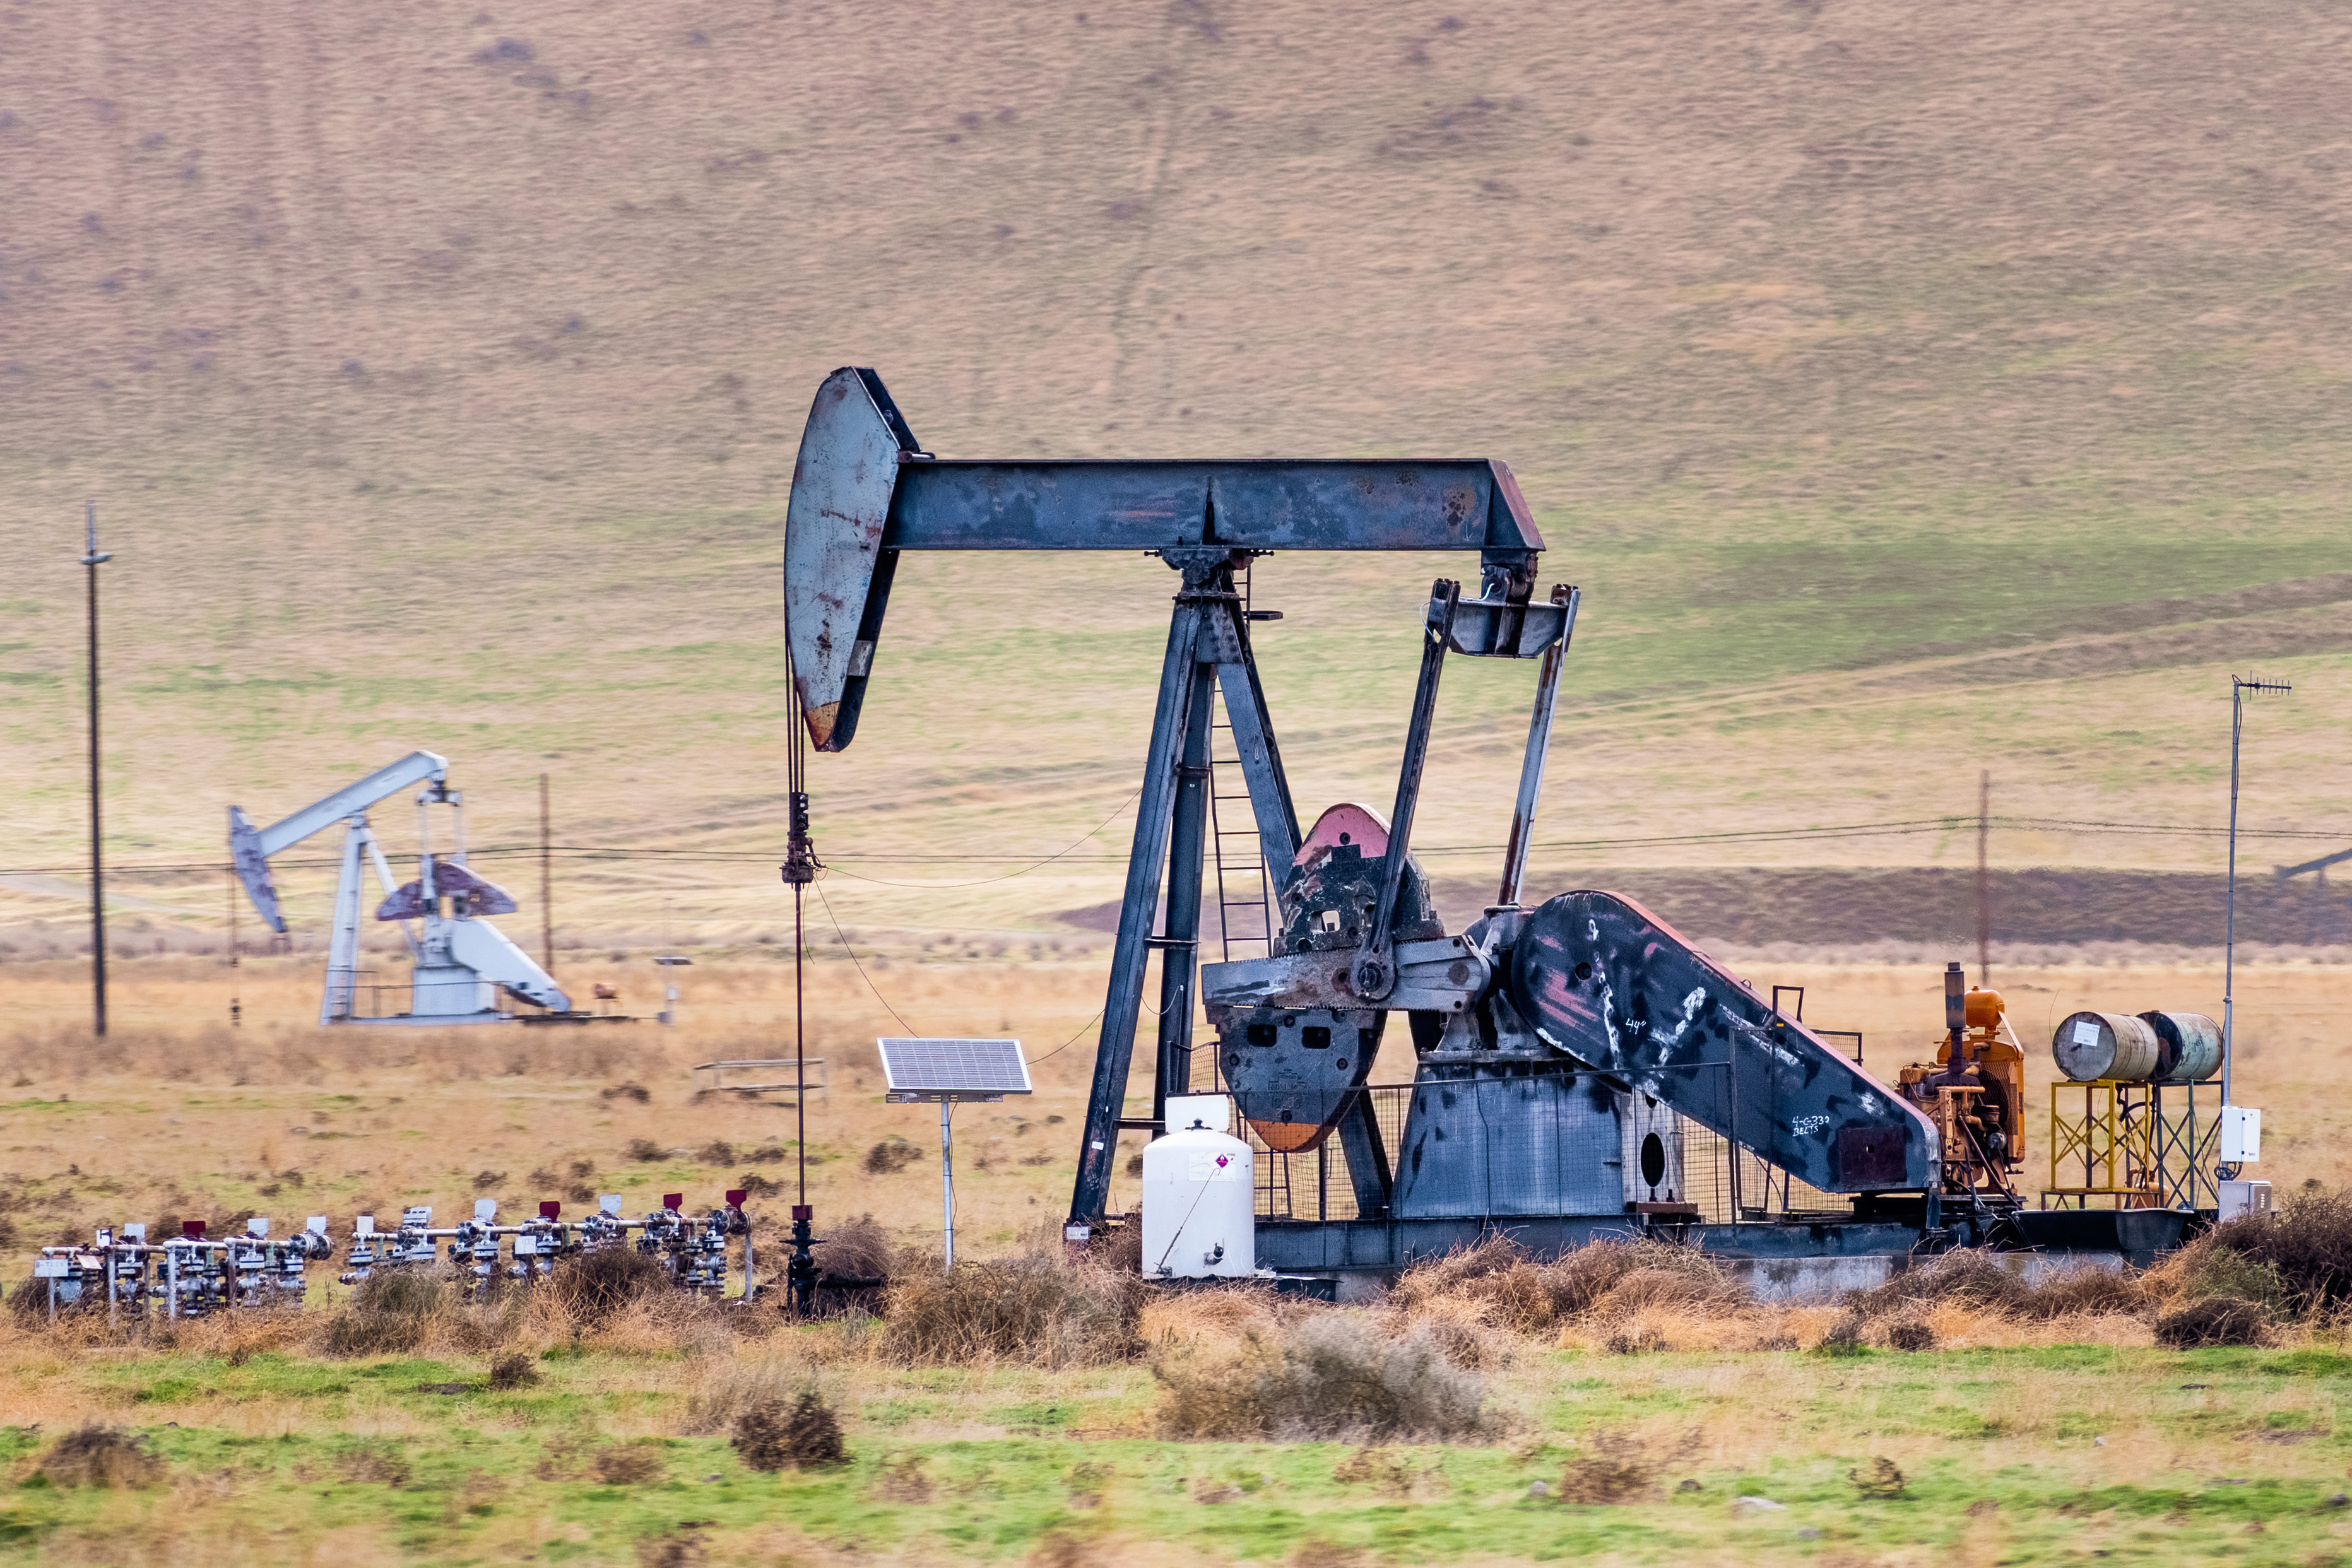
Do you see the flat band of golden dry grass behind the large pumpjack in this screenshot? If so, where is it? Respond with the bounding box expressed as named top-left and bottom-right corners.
top-left (0, 947), bottom-right (2352, 1272)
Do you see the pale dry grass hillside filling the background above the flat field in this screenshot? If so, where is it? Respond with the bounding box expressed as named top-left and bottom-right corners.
top-left (0, 0), bottom-right (2352, 947)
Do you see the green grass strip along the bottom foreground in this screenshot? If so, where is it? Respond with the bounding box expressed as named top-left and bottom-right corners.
top-left (0, 1347), bottom-right (2352, 1564)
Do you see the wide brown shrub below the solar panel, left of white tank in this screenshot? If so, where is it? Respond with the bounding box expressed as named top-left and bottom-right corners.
top-left (882, 1258), bottom-right (1143, 1368)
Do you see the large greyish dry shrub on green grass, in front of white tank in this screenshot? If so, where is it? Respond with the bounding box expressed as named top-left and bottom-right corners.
top-left (1152, 1312), bottom-right (1486, 1444)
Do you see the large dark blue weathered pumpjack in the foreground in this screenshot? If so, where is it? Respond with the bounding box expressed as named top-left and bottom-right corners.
top-left (783, 367), bottom-right (2192, 1272)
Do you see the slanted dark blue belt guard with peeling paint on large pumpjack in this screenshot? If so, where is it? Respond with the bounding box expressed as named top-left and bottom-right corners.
top-left (1510, 893), bottom-right (1938, 1192)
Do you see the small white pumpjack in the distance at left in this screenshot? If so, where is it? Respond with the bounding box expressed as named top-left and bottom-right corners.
top-left (228, 752), bottom-right (572, 1025)
